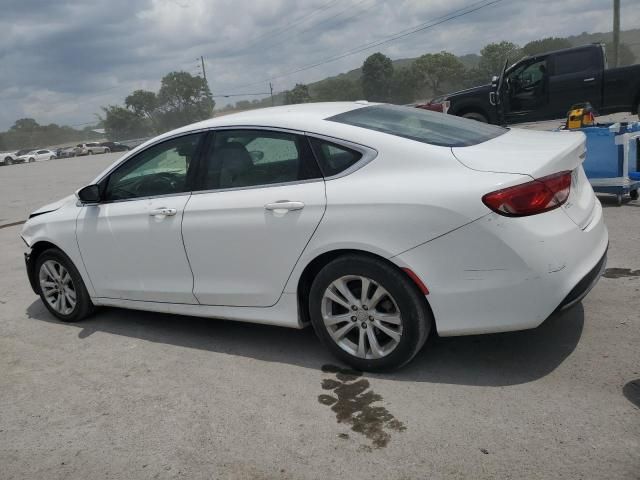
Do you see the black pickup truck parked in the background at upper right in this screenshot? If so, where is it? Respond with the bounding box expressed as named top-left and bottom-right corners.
top-left (418, 44), bottom-right (640, 124)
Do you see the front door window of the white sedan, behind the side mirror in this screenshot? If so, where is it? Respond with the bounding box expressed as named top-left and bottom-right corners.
top-left (105, 133), bottom-right (204, 201)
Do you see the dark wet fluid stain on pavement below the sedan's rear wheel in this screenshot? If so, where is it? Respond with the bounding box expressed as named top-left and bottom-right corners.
top-left (318, 365), bottom-right (407, 448)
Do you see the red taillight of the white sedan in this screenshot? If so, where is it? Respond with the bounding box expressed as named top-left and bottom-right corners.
top-left (482, 172), bottom-right (571, 217)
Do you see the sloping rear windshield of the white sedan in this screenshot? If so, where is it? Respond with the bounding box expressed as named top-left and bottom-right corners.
top-left (327, 105), bottom-right (507, 147)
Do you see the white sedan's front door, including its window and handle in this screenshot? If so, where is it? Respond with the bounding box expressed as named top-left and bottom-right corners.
top-left (77, 134), bottom-right (204, 303)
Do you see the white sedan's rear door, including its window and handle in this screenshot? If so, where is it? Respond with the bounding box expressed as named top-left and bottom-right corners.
top-left (182, 129), bottom-right (326, 307)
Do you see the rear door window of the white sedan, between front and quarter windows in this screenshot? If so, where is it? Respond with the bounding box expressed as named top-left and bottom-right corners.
top-left (203, 130), bottom-right (322, 190)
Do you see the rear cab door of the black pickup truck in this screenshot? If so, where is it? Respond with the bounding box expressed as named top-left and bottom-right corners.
top-left (549, 48), bottom-right (602, 118)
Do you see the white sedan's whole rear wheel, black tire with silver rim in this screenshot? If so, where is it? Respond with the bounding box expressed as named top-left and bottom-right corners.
top-left (309, 254), bottom-right (433, 371)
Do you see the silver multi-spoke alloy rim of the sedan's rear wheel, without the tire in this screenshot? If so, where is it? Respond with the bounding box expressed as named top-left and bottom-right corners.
top-left (321, 275), bottom-right (402, 359)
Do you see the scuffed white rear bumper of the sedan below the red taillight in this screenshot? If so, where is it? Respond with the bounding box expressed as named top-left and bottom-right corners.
top-left (393, 202), bottom-right (609, 336)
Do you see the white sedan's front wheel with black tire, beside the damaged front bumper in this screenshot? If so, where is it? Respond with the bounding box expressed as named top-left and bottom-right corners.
top-left (34, 248), bottom-right (95, 322)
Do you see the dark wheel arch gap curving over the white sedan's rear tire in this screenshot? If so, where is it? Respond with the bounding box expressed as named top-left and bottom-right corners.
top-left (296, 248), bottom-right (433, 325)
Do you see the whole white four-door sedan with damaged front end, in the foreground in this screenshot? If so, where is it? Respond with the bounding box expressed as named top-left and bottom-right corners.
top-left (22, 102), bottom-right (608, 370)
